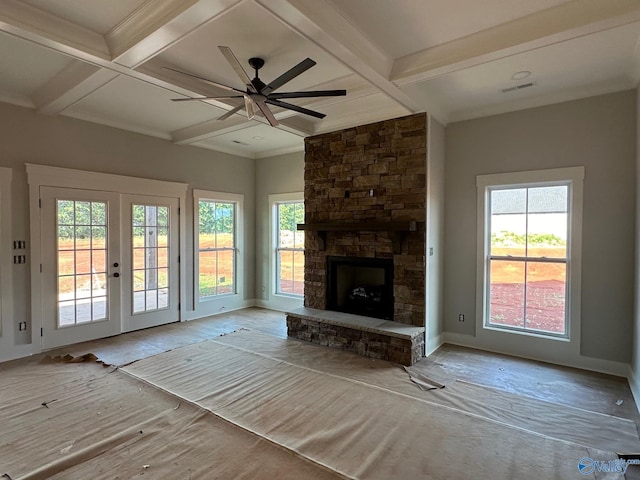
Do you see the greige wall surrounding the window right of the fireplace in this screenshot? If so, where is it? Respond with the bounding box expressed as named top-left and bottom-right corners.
top-left (444, 90), bottom-right (637, 370)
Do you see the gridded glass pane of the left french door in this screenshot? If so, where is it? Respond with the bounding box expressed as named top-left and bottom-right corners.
top-left (56, 200), bottom-right (108, 327)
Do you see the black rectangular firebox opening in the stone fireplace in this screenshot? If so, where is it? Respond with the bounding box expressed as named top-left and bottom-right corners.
top-left (327, 256), bottom-right (393, 320)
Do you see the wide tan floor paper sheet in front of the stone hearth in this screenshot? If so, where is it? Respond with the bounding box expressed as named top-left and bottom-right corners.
top-left (123, 331), bottom-right (638, 480)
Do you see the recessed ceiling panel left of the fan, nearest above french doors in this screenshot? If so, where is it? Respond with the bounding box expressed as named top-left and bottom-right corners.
top-left (64, 75), bottom-right (220, 138)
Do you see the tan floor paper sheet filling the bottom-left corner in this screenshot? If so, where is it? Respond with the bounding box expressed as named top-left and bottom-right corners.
top-left (0, 350), bottom-right (344, 480)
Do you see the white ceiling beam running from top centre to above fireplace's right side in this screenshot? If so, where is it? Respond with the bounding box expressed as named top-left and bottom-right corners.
top-left (254, 0), bottom-right (421, 113)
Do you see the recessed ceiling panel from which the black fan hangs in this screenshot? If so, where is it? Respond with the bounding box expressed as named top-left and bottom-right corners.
top-left (154, 2), bottom-right (351, 91)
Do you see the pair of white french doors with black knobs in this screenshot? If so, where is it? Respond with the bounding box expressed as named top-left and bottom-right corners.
top-left (41, 187), bottom-right (179, 349)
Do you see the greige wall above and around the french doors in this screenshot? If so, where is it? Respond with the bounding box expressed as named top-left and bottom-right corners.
top-left (0, 103), bottom-right (255, 357)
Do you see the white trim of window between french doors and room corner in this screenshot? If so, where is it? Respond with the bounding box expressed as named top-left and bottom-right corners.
top-left (193, 189), bottom-right (244, 316)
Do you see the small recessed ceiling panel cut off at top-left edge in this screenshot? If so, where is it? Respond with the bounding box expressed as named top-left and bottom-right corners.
top-left (22, 0), bottom-right (146, 35)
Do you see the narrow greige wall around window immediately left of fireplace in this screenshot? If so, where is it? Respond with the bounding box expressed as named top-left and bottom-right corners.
top-left (255, 152), bottom-right (304, 310)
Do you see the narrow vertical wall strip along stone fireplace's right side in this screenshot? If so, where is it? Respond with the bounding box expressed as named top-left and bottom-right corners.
top-left (426, 116), bottom-right (445, 355)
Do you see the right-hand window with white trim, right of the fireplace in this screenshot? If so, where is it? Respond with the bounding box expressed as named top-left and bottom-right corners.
top-left (478, 168), bottom-right (583, 339)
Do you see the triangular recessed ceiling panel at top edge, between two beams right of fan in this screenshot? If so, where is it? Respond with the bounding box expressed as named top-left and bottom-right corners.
top-left (332, 0), bottom-right (568, 58)
